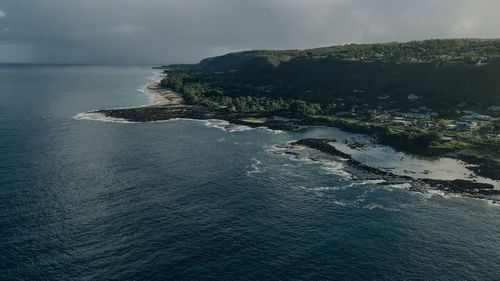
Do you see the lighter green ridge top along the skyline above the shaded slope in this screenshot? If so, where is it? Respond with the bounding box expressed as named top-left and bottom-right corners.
top-left (194, 39), bottom-right (500, 71)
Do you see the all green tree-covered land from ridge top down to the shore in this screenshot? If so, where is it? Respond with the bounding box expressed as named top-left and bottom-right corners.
top-left (161, 39), bottom-right (500, 155)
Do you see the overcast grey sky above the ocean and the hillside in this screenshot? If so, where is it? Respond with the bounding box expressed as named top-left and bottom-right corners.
top-left (0, 0), bottom-right (500, 64)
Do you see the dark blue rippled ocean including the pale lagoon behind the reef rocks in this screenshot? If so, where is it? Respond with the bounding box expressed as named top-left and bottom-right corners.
top-left (0, 65), bottom-right (500, 280)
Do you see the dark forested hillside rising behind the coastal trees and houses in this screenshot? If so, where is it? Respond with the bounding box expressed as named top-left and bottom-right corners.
top-left (170, 39), bottom-right (500, 111)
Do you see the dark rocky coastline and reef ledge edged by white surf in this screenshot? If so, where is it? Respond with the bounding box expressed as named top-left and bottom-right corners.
top-left (95, 84), bottom-right (500, 201)
